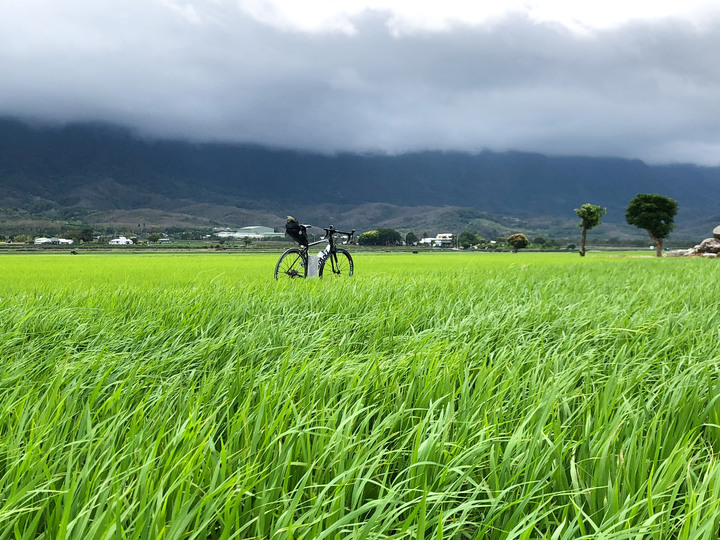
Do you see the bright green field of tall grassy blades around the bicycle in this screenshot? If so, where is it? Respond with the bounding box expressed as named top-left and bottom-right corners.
top-left (0, 253), bottom-right (720, 540)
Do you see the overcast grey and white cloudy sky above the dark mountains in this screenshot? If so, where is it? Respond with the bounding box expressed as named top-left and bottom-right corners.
top-left (0, 0), bottom-right (720, 165)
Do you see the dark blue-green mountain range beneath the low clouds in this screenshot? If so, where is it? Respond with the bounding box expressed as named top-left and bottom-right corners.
top-left (0, 118), bottom-right (720, 241)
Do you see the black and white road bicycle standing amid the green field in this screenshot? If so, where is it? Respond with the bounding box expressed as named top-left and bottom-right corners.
top-left (275, 224), bottom-right (355, 280)
